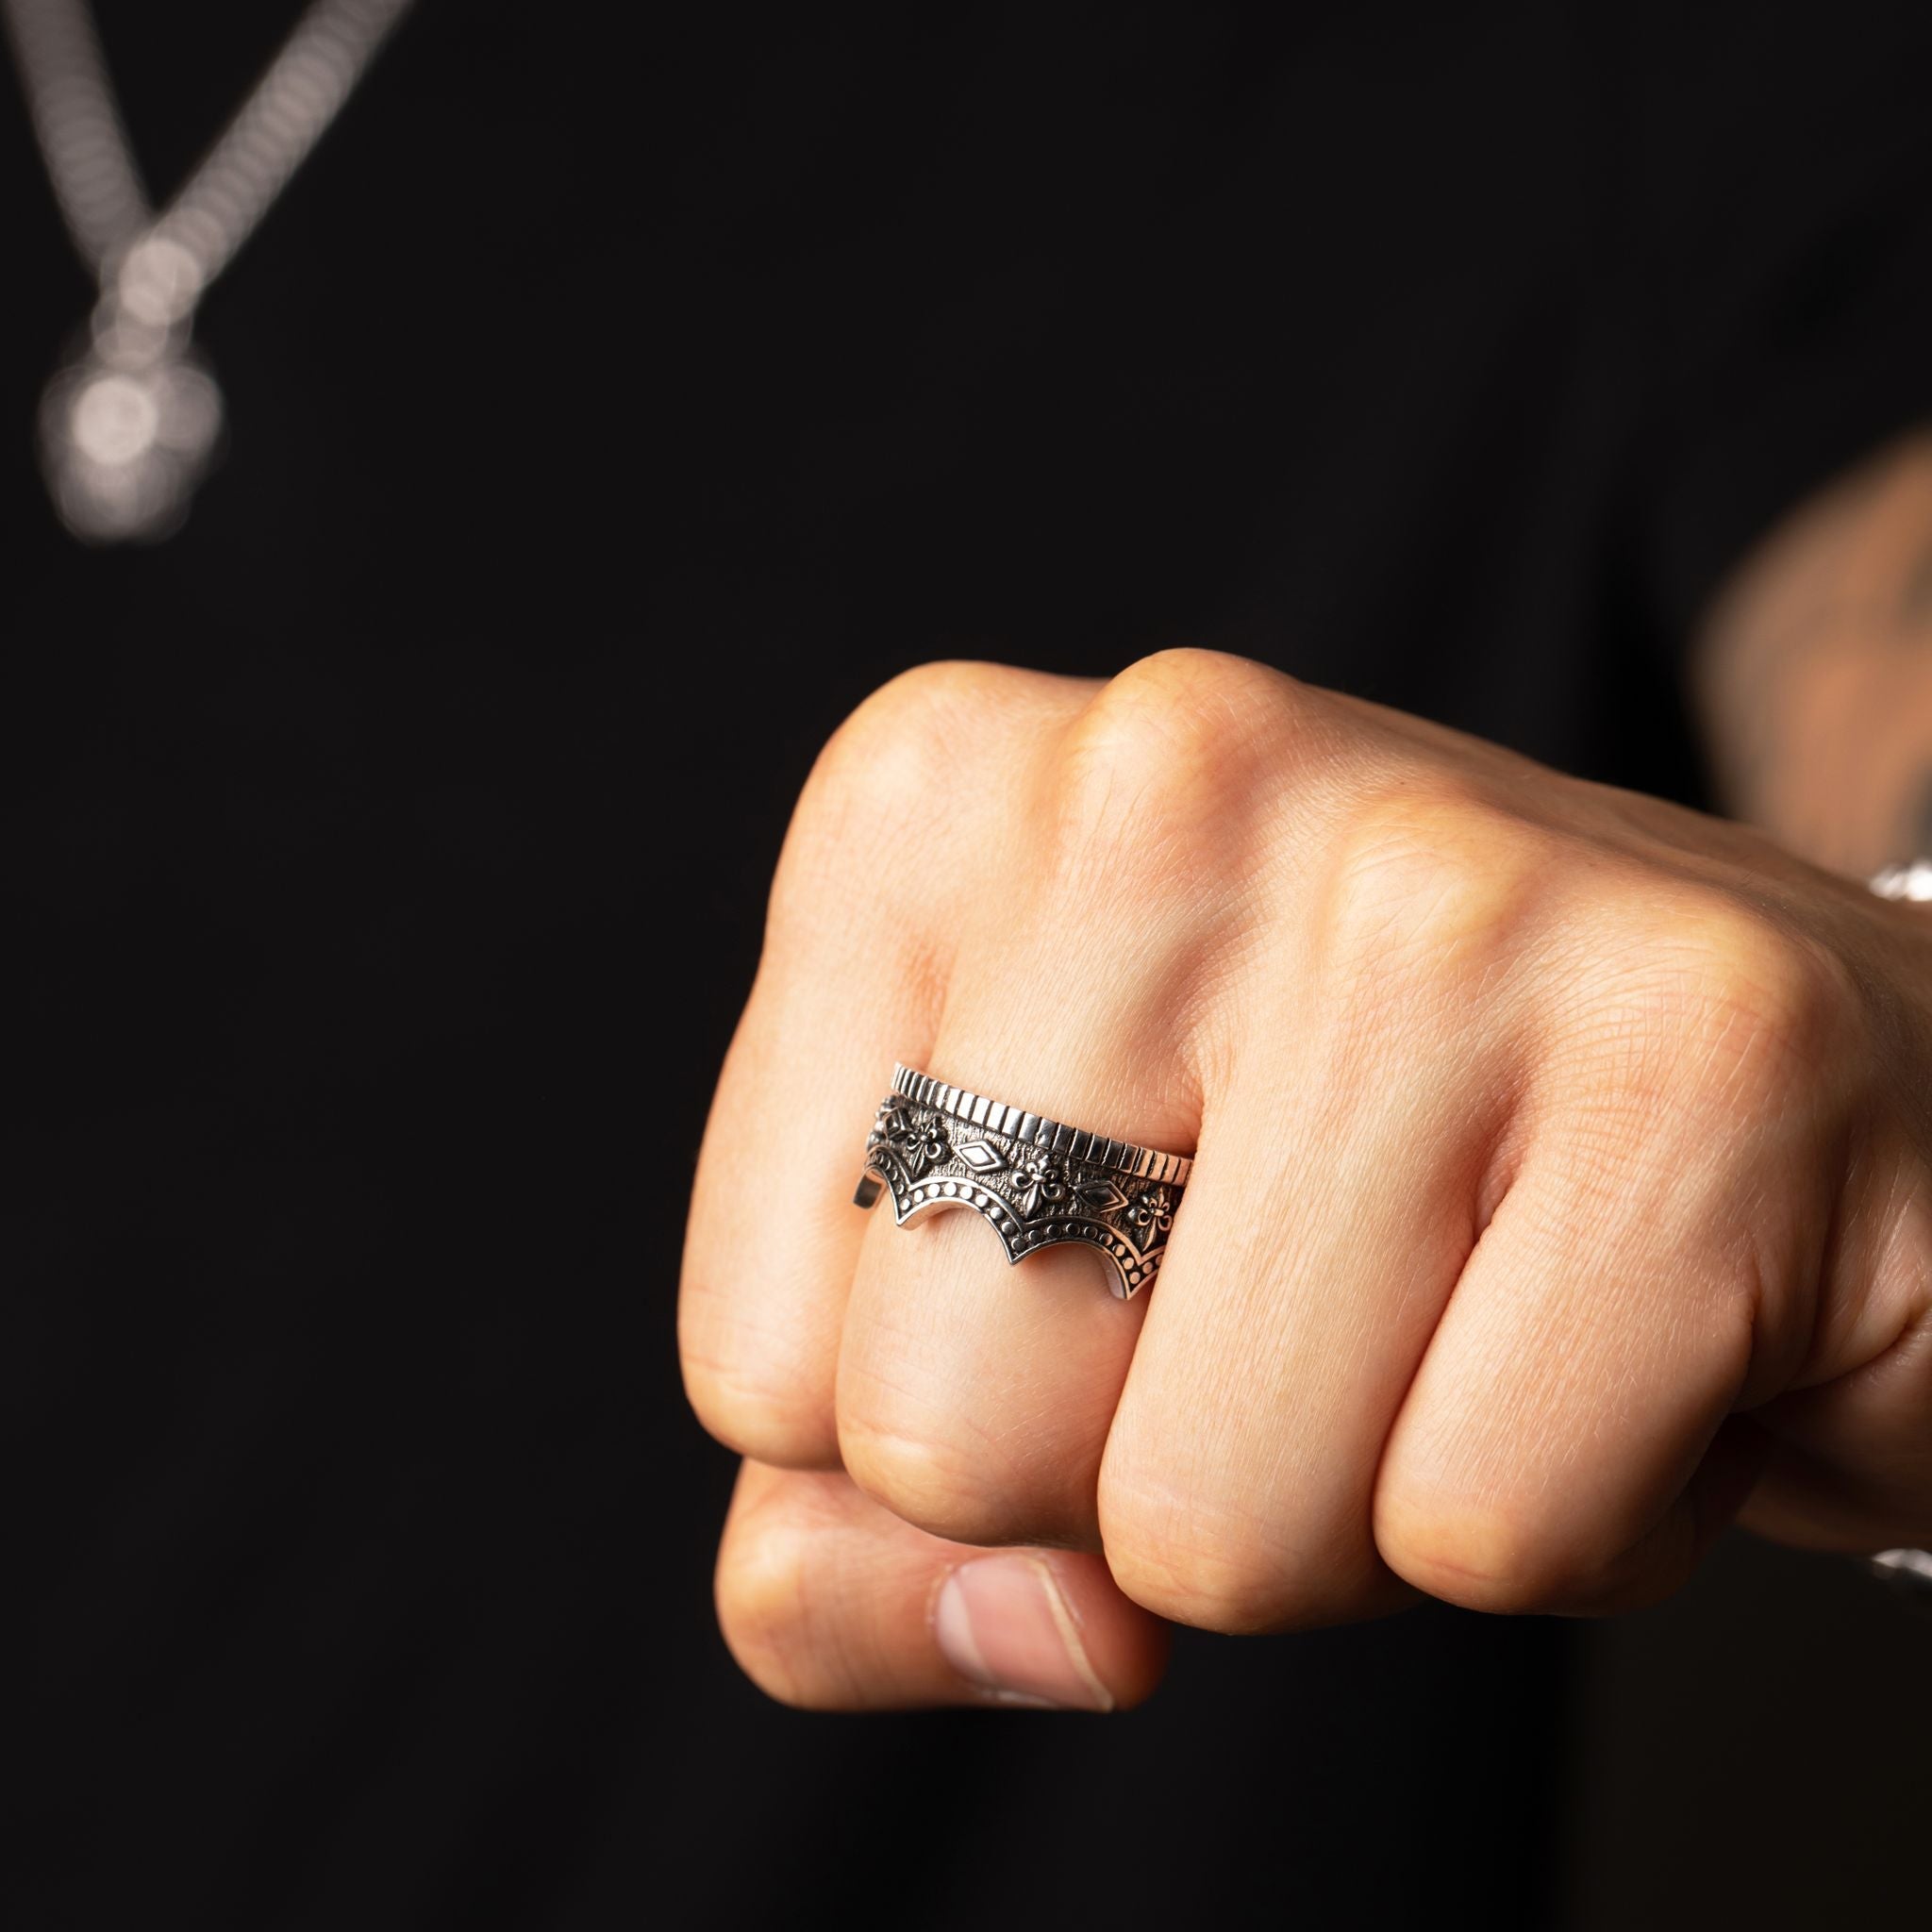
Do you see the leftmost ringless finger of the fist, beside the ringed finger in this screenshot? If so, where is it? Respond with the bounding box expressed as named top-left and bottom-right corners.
top-left (678, 665), bottom-right (1090, 1468)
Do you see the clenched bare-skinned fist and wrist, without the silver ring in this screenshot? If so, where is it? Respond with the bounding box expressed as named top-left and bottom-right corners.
top-left (680, 651), bottom-right (1932, 1704)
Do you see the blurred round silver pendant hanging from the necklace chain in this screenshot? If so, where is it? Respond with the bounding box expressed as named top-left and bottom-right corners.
top-left (41, 328), bottom-right (223, 542)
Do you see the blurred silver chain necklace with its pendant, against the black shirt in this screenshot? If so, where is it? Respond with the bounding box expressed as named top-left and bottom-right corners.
top-left (0, 0), bottom-right (411, 542)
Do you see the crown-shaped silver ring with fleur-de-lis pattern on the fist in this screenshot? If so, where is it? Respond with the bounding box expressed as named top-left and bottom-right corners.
top-left (852, 1066), bottom-right (1194, 1300)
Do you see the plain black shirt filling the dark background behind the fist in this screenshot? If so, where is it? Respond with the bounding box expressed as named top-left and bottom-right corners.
top-left (11, 0), bottom-right (1932, 1928)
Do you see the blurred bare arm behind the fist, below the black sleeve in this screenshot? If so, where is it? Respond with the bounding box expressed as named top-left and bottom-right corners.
top-left (1694, 431), bottom-right (1932, 875)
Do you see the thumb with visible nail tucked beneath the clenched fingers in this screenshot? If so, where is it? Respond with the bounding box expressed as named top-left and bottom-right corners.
top-left (717, 1462), bottom-right (1169, 1709)
